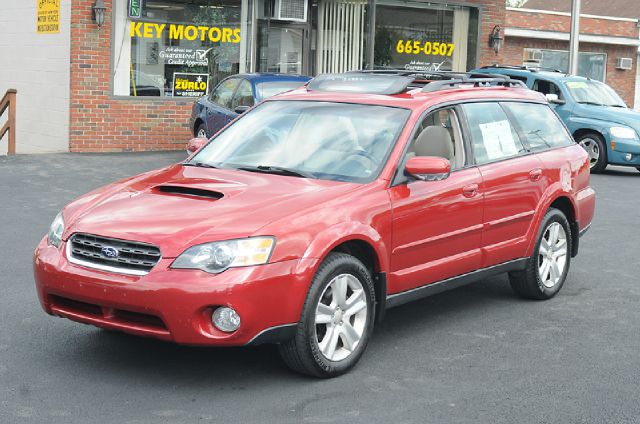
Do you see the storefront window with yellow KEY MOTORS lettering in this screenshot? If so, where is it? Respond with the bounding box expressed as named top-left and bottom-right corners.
top-left (114, 0), bottom-right (248, 97)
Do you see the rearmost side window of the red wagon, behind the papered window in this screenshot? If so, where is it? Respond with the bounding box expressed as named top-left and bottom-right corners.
top-left (503, 103), bottom-right (573, 151)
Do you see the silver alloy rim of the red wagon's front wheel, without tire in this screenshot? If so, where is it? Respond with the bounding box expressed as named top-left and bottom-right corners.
top-left (315, 274), bottom-right (368, 362)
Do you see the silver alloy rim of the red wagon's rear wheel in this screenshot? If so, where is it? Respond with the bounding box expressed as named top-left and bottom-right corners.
top-left (538, 222), bottom-right (567, 288)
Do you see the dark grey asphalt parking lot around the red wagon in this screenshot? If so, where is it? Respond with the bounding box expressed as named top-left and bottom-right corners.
top-left (0, 152), bottom-right (640, 424)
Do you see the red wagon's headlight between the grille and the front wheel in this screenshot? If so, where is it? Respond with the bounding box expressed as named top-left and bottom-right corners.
top-left (171, 237), bottom-right (275, 274)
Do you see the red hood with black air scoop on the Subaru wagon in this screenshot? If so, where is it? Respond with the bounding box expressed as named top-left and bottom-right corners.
top-left (63, 165), bottom-right (360, 258)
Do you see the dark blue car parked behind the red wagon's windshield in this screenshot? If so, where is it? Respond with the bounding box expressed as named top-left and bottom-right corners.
top-left (189, 73), bottom-right (311, 138)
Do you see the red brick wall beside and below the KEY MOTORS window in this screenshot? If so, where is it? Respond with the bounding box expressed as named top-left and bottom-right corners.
top-left (69, 0), bottom-right (192, 152)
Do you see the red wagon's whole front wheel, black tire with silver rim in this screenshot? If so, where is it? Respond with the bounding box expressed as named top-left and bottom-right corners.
top-left (279, 253), bottom-right (375, 378)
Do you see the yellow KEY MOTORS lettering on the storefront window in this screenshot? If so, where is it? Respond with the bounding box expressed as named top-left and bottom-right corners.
top-left (130, 22), bottom-right (240, 43)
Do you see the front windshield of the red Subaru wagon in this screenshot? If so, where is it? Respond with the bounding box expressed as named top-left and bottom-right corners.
top-left (187, 101), bottom-right (410, 182)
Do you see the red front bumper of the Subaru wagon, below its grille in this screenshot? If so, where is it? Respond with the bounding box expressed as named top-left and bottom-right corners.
top-left (34, 238), bottom-right (317, 346)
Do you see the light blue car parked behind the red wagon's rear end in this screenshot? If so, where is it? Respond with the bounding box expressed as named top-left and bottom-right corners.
top-left (473, 66), bottom-right (640, 173)
